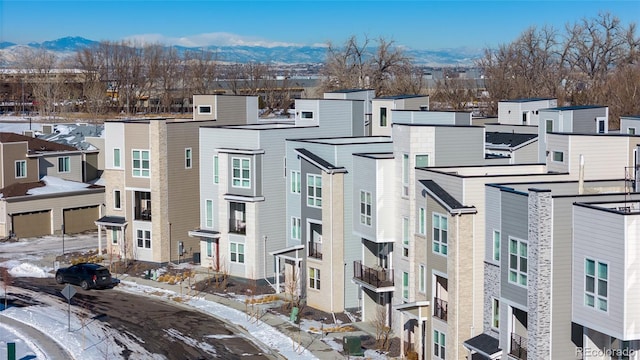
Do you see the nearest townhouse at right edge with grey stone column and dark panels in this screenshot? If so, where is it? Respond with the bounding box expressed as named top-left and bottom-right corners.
top-left (476, 179), bottom-right (640, 359)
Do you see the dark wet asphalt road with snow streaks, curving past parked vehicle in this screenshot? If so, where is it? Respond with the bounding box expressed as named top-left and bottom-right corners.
top-left (12, 277), bottom-right (274, 360)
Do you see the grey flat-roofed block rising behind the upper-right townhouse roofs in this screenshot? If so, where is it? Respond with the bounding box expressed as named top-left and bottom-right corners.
top-left (538, 105), bottom-right (609, 162)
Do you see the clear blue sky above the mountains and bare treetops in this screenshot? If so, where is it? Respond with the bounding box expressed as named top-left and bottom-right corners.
top-left (0, 0), bottom-right (640, 49)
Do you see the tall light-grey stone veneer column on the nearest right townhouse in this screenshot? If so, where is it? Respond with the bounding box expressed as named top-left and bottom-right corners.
top-left (527, 189), bottom-right (553, 359)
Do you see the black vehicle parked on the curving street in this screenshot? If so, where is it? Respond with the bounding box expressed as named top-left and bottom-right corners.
top-left (56, 263), bottom-right (120, 290)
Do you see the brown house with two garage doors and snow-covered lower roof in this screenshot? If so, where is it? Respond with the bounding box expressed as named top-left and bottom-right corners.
top-left (0, 132), bottom-right (104, 238)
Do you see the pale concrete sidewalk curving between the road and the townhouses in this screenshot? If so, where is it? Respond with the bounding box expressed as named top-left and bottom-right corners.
top-left (116, 274), bottom-right (373, 360)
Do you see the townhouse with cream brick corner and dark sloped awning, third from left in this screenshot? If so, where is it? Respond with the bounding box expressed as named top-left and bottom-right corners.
top-left (276, 136), bottom-right (392, 313)
